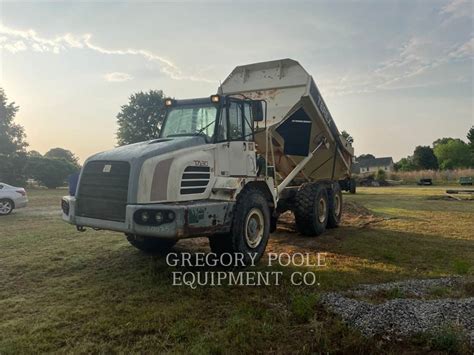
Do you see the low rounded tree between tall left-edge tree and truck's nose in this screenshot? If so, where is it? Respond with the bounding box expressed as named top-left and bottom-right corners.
top-left (27, 156), bottom-right (77, 189)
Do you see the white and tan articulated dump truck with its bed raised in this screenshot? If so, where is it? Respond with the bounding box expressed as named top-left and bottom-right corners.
top-left (62, 59), bottom-right (353, 263)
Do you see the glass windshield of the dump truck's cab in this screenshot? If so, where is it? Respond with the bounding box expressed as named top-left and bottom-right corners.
top-left (161, 105), bottom-right (217, 140)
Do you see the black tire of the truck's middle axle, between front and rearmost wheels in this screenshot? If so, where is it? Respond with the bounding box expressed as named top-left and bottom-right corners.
top-left (293, 184), bottom-right (329, 236)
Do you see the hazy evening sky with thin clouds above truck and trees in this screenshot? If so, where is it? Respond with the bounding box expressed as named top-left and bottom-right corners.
top-left (0, 0), bottom-right (474, 161)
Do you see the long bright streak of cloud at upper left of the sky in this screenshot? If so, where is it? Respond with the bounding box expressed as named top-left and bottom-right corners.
top-left (0, 23), bottom-right (217, 83)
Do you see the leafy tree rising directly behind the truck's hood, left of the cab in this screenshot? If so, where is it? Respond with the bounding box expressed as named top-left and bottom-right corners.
top-left (117, 90), bottom-right (166, 145)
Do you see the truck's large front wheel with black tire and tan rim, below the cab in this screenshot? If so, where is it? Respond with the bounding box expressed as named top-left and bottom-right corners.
top-left (209, 188), bottom-right (270, 265)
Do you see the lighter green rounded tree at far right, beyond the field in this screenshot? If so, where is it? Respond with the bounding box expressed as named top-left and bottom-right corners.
top-left (433, 138), bottom-right (472, 169)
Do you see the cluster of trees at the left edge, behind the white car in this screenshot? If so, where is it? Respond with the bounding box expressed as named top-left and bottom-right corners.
top-left (0, 88), bottom-right (80, 188)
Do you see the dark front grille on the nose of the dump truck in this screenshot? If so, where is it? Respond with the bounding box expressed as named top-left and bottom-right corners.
top-left (76, 161), bottom-right (130, 222)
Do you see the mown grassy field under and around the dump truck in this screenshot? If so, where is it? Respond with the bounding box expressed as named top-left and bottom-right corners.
top-left (0, 187), bottom-right (474, 354)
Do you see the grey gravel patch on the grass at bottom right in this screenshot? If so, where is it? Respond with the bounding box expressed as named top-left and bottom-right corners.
top-left (321, 278), bottom-right (474, 346)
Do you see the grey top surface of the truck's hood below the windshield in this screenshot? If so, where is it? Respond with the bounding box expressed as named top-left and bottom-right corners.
top-left (85, 136), bottom-right (206, 168)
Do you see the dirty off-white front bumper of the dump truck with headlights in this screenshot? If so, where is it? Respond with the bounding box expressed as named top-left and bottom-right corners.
top-left (62, 196), bottom-right (234, 239)
